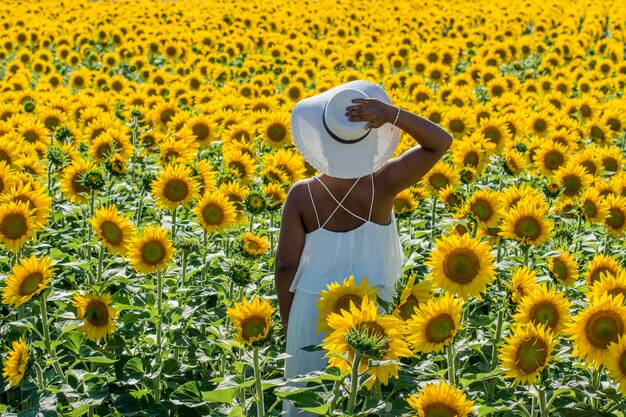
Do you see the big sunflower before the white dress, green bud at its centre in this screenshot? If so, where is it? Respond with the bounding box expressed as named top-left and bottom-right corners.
top-left (323, 295), bottom-right (412, 388)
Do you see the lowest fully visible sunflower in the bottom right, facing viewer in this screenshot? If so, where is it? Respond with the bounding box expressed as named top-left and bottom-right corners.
top-left (498, 323), bottom-right (555, 386)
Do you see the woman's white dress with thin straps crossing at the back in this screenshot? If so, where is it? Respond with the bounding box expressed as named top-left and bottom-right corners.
top-left (283, 176), bottom-right (403, 417)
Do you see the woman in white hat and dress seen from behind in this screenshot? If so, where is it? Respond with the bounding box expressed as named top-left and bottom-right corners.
top-left (274, 81), bottom-right (452, 415)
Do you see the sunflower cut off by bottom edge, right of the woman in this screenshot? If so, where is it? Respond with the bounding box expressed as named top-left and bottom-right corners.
top-left (407, 381), bottom-right (474, 417)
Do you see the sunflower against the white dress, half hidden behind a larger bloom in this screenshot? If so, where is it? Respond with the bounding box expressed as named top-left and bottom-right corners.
top-left (317, 275), bottom-right (376, 333)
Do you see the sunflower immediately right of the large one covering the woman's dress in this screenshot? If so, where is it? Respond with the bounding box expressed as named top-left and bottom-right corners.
top-left (406, 294), bottom-right (463, 352)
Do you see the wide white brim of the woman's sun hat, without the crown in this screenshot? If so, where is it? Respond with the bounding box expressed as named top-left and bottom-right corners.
top-left (291, 80), bottom-right (400, 178)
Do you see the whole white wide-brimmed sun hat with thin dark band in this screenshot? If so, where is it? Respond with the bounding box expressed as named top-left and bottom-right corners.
top-left (291, 80), bottom-right (400, 178)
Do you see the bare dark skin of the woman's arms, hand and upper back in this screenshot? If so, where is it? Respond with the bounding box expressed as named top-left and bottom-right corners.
top-left (274, 99), bottom-right (452, 333)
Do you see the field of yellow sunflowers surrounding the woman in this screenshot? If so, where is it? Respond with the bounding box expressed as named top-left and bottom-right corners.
top-left (0, 0), bottom-right (626, 417)
